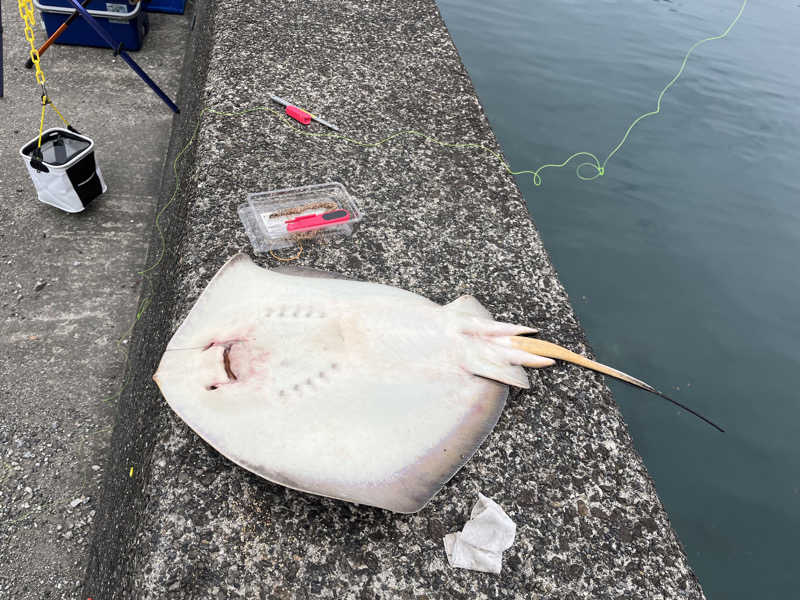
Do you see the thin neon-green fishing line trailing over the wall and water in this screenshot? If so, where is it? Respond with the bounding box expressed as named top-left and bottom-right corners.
top-left (106, 0), bottom-right (748, 401)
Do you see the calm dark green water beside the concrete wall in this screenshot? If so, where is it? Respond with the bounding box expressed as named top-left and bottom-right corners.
top-left (439, 0), bottom-right (800, 600)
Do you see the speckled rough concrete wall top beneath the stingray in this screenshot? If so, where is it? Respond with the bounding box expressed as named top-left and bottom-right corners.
top-left (84, 0), bottom-right (703, 599)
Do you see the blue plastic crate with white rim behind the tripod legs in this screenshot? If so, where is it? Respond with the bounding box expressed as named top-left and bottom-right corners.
top-left (33, 0), bottom-right (150, 50)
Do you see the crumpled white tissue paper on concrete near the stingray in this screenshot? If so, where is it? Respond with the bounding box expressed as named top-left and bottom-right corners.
top-left (444, 493), bottom-right (517, 574)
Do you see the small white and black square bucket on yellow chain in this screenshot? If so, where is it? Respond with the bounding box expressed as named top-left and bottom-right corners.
top-left (19, 127), bottom-right (108, 213)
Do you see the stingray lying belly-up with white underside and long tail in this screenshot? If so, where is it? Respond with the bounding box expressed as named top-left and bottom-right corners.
top-left (153, 254), bottom-right (716, 513)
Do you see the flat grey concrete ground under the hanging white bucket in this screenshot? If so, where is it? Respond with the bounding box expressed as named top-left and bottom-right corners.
top-left (0, 0), bottom-right (190, 600)
